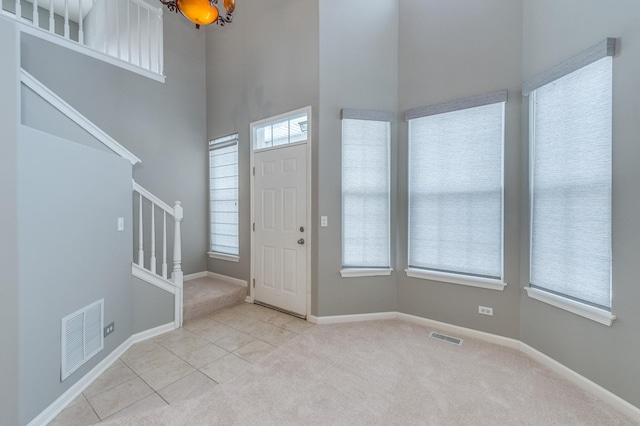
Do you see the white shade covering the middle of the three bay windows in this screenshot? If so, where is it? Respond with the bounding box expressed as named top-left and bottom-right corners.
top-left (409, 102), bottom-right (504, 279)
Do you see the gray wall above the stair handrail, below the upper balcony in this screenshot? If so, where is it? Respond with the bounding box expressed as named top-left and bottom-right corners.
top-left (21, 12), bottom-right (207, 274)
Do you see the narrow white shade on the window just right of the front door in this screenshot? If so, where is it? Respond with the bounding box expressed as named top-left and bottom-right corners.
top-left (342, 119), bottom-right (391, 268)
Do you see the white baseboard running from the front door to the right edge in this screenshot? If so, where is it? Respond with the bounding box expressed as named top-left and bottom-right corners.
top-left (308, 312), bottom-right (640, 422)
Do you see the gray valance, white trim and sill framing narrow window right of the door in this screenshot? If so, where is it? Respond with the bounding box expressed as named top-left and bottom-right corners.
top-left (340, 108), bottom-right (395, 272)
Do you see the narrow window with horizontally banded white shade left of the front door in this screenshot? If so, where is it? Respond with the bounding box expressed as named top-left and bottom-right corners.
top-left (209, 134), bottom-right (239, 260)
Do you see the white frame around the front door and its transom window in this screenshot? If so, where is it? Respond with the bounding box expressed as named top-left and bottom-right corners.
top-left (249, 106), bottom-right (313, 321)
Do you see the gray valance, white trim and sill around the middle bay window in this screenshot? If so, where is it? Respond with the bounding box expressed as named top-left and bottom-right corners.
top-left (405, 89), bottom-right (508, 291)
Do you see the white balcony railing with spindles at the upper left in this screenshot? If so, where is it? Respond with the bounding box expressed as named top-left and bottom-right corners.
top-left (1, 0), bottom-right (164, 81)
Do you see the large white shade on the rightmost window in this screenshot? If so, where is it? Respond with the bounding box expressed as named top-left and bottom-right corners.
top-left (530, 57), bottom-right (612, 309)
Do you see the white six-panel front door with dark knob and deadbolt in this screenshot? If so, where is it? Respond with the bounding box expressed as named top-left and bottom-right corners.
top-left (253, 144), bottom-right (308, 315)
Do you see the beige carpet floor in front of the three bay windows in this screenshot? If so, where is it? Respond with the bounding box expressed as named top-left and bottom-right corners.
top-left (100, 320), bottom-right (636, 426)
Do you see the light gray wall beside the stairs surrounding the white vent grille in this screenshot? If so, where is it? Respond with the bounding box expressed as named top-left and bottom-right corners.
top-left (18, 126), bottom-right (133, 424)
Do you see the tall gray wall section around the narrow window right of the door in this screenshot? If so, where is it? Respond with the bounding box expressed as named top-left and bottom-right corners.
top-left (313, 0), bottom-right (401, 316)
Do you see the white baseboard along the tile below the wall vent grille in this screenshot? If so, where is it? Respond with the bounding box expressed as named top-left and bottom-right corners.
top-left (28, 322), bottom-right (175, 426)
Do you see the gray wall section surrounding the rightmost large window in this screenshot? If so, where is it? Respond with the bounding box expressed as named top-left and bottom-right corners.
top-left (520, 0), bottom-right (640, 406)
